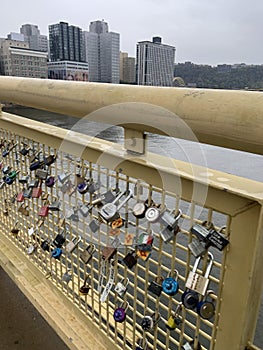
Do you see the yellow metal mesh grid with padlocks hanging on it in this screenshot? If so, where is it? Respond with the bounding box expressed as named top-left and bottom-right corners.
top-left (0, 130), bottom-right (231, 349)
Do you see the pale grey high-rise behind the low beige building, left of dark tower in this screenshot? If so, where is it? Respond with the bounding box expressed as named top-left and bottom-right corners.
top-left (20, 24), bottom-right (48, 52)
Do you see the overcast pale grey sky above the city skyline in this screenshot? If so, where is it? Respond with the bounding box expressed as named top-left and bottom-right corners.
top-left (0, 0), bottom-right (263, 65)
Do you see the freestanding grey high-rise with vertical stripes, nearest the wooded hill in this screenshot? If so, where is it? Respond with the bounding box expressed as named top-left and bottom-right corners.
top-left (136, 37), bottom-right (175, 86)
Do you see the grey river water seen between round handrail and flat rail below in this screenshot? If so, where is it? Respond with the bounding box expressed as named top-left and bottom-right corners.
top-left (4, 107), bottom-right (263, 350)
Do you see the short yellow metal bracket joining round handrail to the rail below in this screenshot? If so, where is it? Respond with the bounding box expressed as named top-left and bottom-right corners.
top-left (124, 128), bottom-right (147, 154)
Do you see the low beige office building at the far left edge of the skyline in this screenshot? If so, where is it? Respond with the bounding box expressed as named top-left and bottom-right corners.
top-left (0, 39), bottom-right (48, 78)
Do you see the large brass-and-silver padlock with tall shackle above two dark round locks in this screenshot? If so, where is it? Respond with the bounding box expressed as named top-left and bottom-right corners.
top-left (185, 252), bottom-right (214, 296)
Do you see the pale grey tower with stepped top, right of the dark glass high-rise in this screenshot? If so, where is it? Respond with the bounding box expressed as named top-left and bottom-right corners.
top-left (84, 20), bottom-right (120, 84)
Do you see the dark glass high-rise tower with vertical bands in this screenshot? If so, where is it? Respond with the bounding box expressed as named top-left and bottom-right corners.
top-left (49, 22), bottom-right (85, 62)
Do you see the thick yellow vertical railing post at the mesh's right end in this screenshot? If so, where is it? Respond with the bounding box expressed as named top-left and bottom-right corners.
top-left (213, 203), bottom-right (263, 350)
